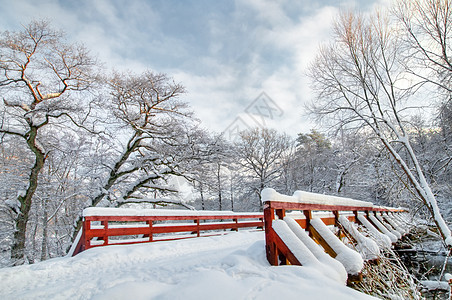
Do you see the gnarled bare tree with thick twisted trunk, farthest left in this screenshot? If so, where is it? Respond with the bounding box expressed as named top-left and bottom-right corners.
top-left (0, 22), bottom-right (96, 264)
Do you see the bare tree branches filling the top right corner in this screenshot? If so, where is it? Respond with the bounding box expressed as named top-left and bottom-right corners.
top-left (393, 0), bottom-right (452, 93)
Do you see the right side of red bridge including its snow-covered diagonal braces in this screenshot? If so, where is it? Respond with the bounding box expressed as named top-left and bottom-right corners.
top-left (261, 188), bottom-right (408, 282)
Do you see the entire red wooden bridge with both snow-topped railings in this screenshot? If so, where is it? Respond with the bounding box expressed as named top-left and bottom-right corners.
top-left (72, 189), bottom-right (410, 280)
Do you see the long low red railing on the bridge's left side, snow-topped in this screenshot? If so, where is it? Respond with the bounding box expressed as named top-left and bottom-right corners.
top-left (72, 208), bottom-right (264, 255)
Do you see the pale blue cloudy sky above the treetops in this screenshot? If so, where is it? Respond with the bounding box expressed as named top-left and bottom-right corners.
top-left (0, 0), bottom-right (387, 139)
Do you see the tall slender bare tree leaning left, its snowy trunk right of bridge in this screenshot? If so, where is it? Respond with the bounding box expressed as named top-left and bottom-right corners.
top-left (310, 13), bottom-right (452, 246)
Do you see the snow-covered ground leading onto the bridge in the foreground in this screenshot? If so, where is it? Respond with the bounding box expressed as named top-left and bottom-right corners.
top-left (0, 231), bottom-right (375, 300)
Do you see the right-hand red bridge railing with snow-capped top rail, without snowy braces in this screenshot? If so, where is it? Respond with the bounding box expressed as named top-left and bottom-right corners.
top-left (262, 189), bottom-right (405, 280)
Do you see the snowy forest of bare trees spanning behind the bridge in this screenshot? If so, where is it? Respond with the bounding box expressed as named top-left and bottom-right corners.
top-left (0, 0), bottom-right (452, 267)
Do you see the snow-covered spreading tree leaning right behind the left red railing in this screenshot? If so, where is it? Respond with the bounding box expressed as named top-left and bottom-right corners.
top-left (69, 71), bottom-right (191, 237)
